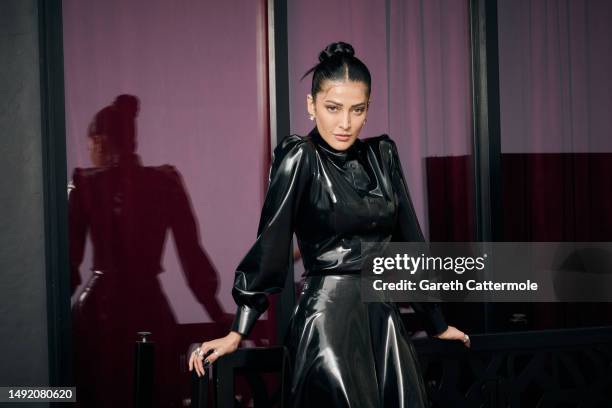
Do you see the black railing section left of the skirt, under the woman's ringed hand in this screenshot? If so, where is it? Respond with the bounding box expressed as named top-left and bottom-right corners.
top-left (190, 345), bottom-right (291, 408)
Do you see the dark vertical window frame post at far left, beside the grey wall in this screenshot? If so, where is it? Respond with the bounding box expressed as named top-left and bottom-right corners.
top-left (38, 0), bottom-right (74, 390)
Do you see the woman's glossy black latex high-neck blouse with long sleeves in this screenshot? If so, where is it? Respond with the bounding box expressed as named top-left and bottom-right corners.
top-left (232, 128), bottom-right (447, 335)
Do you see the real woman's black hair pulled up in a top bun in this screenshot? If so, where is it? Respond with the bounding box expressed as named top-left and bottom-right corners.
top-left (302, 42), bottom-right (372, 98)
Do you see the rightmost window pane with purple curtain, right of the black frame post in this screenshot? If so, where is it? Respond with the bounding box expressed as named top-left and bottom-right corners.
top-left (496, 0), bottom-right (612, 329)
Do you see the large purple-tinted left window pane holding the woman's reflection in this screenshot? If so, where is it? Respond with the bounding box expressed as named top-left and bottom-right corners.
top-left (63, 0), bottom-right (274, 407)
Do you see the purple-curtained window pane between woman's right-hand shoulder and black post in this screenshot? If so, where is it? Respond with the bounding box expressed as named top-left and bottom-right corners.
top-left (388, 0), bottom-right (475, 241)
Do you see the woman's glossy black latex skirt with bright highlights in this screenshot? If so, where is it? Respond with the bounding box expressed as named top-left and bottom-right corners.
top-left (286, 275), bottom-right (428, 408)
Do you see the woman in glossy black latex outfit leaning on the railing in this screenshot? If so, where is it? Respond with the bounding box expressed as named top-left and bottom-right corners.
top-left (190, 43), bottom-right (469, 407)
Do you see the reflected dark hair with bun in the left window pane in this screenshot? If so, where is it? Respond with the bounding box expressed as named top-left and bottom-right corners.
top-left (88, 94), bottom-right (140, 154)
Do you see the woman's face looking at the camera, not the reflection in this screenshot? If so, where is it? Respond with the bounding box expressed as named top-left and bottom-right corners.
top-left (307, 80), bottom-right (369, 150)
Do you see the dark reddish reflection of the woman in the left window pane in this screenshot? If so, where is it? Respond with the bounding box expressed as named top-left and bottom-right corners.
top-left (69, 95), bottom-right (224, 407)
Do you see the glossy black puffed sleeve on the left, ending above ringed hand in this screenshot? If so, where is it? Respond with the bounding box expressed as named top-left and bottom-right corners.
top-left (232, 136), bottom-right (311, 336)
